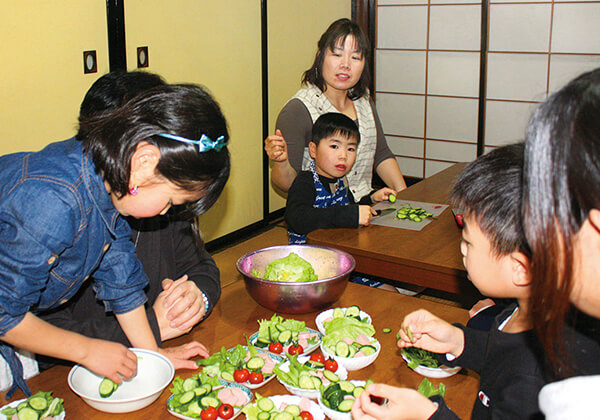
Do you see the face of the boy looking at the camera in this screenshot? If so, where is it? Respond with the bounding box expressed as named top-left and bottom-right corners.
top-left (308, 133), bottom-right (358, 178)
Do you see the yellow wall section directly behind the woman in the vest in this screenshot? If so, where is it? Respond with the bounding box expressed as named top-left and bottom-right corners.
top-left (268, 0), bottom-right (352, 212)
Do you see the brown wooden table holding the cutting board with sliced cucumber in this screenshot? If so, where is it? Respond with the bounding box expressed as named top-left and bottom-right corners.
top-left (307, 163), bottom-right (478, 296)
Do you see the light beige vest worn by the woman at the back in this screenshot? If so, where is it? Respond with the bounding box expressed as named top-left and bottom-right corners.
top-left (294, 84), bottom-right (377, 200)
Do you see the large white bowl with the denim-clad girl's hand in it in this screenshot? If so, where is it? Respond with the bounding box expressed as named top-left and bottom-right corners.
top-left (68, 348), bottom-right (175, 413)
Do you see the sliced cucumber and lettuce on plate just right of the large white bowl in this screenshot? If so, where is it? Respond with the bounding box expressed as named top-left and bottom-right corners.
top-left (168, 372), bottom-right (234, 418)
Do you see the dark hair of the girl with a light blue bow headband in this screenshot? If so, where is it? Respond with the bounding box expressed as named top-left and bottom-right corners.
top-left (79, 84), bottom-right (230, 215)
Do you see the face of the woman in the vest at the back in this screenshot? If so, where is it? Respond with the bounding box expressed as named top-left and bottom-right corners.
top-left (321, 35), bottom-right (365, 92)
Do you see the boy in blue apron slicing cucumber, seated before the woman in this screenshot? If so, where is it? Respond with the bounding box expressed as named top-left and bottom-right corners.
top-left (285, 112), bottom-right (395, 244)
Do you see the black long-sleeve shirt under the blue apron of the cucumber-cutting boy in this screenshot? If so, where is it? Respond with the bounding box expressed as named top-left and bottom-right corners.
top-left (285, 171), bottom-right (373, 235)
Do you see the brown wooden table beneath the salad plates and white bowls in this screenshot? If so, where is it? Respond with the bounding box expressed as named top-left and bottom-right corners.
top-left (0, 281), bottom-right (479, 420)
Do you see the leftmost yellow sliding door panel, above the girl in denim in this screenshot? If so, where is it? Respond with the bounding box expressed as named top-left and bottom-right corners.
top-left (0, 0), bottom-right (108, 155)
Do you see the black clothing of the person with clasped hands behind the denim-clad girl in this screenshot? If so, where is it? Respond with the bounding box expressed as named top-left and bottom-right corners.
top-left (38, 212), bottom-right (221, 363)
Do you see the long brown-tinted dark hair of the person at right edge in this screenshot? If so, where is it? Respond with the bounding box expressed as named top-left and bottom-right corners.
top-left (522, 68), bottom-right (600, 370)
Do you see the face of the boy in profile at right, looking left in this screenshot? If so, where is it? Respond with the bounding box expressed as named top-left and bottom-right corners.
top-left (460, 216), bottom-right (529, 298)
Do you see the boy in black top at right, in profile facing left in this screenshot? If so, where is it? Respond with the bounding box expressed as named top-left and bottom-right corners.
top-left (352, 143), bottom-right (600, 420)
